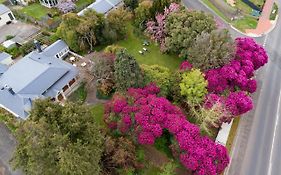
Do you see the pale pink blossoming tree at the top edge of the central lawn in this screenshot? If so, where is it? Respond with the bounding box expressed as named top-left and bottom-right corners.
top-left (146, 3), bottom-right (180, 51)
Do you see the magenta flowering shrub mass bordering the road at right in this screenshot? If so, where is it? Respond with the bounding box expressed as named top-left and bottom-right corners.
top-left (205, 38), bottom-right (268, 94)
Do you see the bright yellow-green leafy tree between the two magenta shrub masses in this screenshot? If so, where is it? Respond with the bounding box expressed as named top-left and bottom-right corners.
top-left (179, 69), bottom-right (208, 104)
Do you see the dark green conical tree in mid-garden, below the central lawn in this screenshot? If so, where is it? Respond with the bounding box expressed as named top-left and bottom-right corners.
top-left (114, 50), bottom-right (143, 91)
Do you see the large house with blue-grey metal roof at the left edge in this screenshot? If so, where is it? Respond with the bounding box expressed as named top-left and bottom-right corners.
top-left (0, 41), bottom-right (78, 119)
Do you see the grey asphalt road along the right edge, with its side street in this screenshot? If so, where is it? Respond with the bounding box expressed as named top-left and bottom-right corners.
top-left (183, 0), bottom-right (281, 175)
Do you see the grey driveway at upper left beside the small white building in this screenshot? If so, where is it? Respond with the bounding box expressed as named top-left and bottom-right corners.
top-left (0, 21), bottom-right (40, 44)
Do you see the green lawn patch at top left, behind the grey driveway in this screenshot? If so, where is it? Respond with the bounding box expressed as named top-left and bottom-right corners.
top-left (21, 3), bottom-right (55, 20)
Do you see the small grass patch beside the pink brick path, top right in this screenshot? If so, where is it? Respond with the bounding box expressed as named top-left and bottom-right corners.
top-left (232, 16), bottom-right (258, 32)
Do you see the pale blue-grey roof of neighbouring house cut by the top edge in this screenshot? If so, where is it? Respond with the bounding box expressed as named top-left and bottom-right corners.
top-left (77, 0), bottom-right (122, 16)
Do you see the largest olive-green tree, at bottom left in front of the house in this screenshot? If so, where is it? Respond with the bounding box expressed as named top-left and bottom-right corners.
top-left (12, 100), bottom-right (103, 175)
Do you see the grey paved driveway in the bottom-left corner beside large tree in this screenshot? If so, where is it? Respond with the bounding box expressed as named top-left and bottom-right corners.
top-left (0, 122), bottom-right (22, 175)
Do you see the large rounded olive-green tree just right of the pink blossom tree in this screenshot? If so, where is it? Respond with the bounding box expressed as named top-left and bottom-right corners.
top-left (165, 9), bottom-right (216, 58)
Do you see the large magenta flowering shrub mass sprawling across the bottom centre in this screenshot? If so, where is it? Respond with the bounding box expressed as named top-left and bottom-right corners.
top-left (104, 84), bottom-right (229, 175)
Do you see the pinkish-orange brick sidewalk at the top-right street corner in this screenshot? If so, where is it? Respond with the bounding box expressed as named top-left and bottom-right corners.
top-left (245, 0), bottom-right (274, 36)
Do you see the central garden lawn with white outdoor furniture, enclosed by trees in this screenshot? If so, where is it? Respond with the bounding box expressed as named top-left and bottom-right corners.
top-left (115, 25), bottom-right (181, 70)
